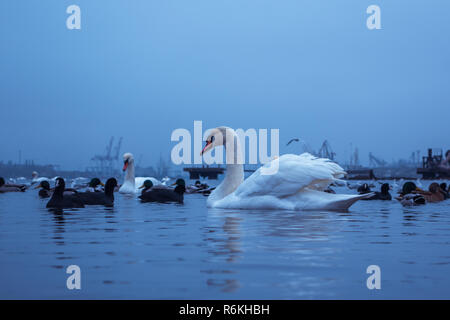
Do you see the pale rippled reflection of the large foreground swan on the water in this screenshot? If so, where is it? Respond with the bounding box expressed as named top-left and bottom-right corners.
top-left (203, 209), bottom-right (352, 292)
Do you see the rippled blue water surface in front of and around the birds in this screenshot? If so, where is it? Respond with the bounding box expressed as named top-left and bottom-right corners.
top-left (0, 182), bottom-right (450, 299)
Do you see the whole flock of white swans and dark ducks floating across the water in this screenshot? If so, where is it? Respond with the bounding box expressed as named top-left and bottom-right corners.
top-left (0, 127), bottom-right (448, 211)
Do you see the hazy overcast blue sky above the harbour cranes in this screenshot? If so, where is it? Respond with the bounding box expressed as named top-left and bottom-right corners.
top-left (0, 0), bottom-right (450, 169)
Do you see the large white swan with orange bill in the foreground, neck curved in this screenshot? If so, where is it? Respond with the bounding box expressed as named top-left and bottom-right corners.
top-left (201, 127), bottom-right (372, 210)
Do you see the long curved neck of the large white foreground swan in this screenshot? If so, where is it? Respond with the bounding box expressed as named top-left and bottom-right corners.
top-left (208, 129), bottom-right (244, 204)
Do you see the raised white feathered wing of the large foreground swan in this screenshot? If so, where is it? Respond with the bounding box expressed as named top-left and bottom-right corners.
top-left (235, 153), bottom-right (345, 198)
